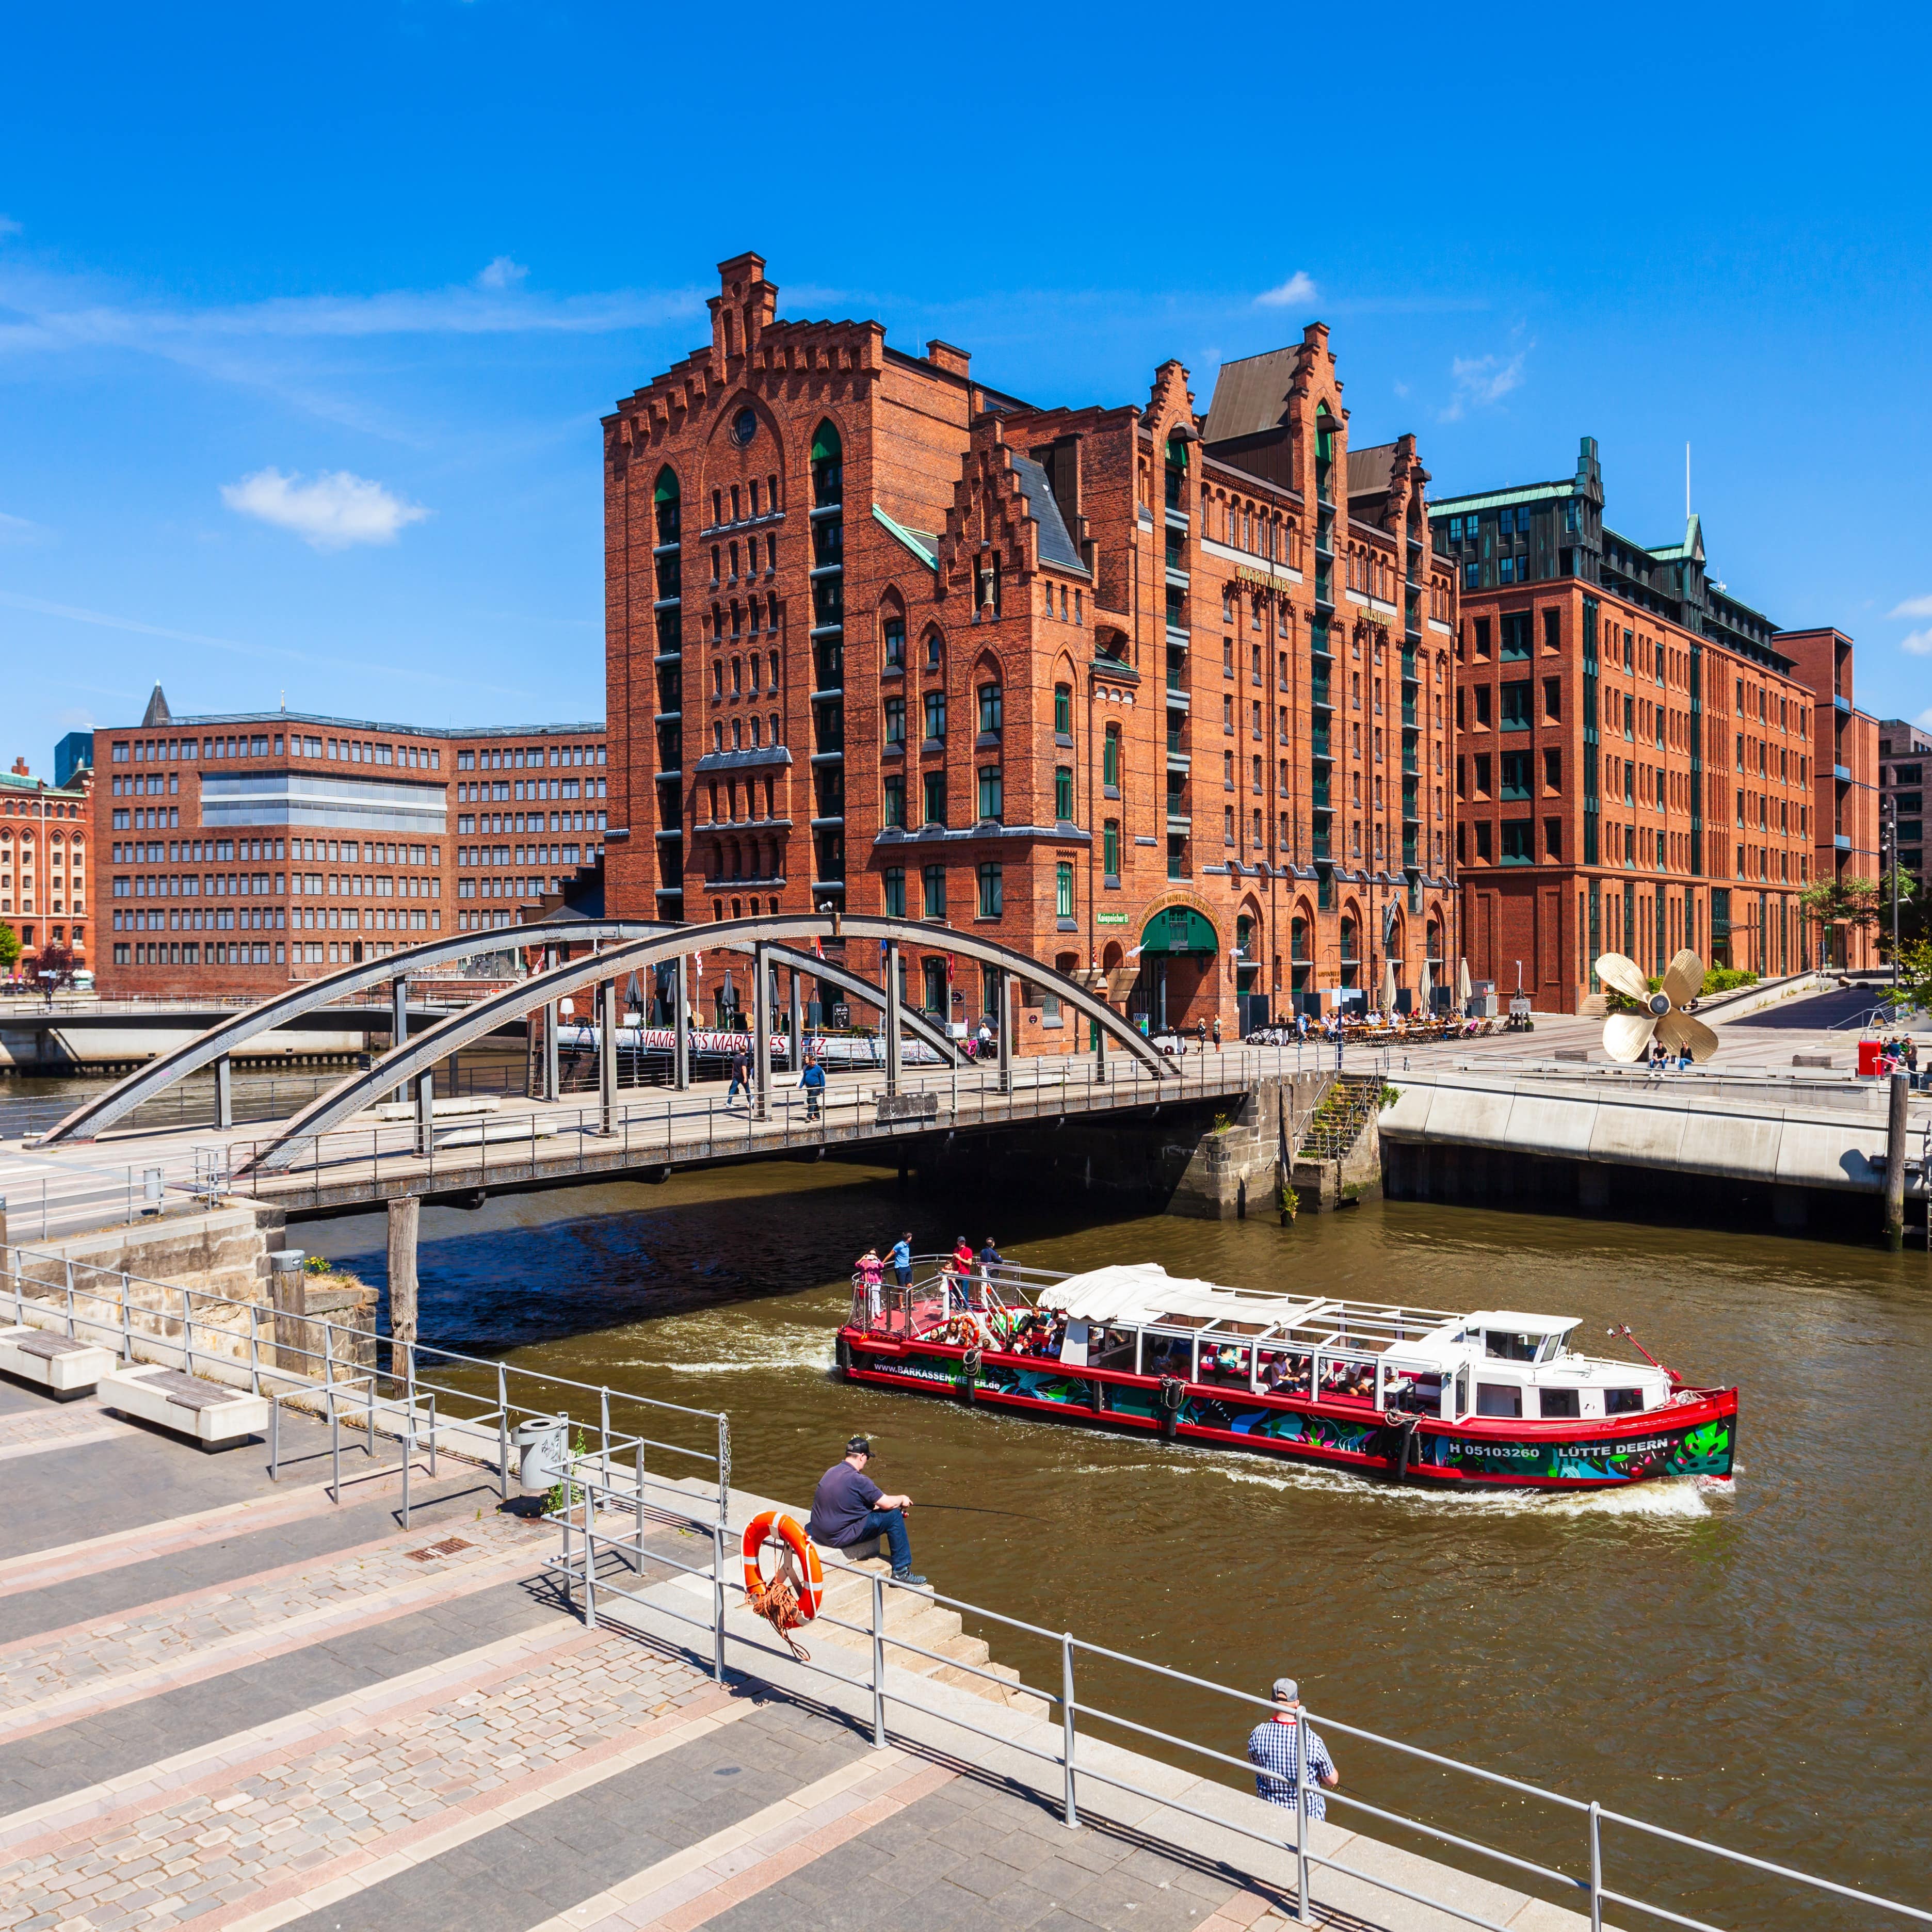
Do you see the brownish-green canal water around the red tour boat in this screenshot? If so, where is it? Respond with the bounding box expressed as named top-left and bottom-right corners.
top-left (296, 1163), bottom-right (1932, 1926)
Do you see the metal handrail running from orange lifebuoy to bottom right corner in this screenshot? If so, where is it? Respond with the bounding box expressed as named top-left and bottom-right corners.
top-left (549, 1457), bottom-right (1932, 1932)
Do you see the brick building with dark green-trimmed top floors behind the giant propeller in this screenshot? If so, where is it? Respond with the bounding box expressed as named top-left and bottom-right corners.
top-left (1430, 437), bottom-right (1862, 1012)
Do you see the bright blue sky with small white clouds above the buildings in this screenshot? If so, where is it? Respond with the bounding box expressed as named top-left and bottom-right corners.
top-left (0, 0), bottom-right (1932, 771)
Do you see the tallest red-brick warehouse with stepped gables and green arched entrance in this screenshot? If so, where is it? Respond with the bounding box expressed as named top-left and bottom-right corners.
top-left (605, 255), bottom-right (1455, 1051)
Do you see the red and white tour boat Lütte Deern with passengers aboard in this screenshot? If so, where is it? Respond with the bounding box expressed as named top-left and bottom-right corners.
top-left (839, 1264), bottom-right (1737, 1490)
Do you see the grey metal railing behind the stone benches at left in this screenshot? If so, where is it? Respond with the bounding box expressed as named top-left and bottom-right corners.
top-left (0, 1246), bottom-right (730, 1526)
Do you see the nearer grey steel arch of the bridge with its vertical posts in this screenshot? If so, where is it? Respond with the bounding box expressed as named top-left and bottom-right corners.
top-left (249, 912), bottom-right (1179, 1173)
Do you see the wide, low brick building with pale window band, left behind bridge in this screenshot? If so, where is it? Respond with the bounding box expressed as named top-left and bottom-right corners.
top-left (94, 686), bottom-right (608, 997)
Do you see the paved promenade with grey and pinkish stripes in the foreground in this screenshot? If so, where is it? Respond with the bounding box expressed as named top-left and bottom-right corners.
top-left (0, 1360), bottom-right (1581, 1932)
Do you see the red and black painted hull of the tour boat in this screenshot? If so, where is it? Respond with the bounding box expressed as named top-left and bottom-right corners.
top-left (839, 1329), bottom-right (1737, 1490)
